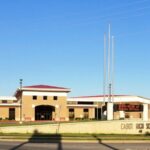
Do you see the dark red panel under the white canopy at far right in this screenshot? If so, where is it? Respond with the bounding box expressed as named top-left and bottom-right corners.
top-left (114, 104), bottom-right (143, 112)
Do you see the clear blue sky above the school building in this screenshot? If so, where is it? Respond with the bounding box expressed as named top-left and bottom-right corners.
top-left (0, 0), bottom-right (150, 98)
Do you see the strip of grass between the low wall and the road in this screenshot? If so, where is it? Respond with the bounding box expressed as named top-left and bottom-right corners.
top-left (0, 133), bottom-right (150, 141)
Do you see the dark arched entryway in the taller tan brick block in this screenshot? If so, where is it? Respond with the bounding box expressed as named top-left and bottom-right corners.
top-left (35, 105), bottom-right (55, 120)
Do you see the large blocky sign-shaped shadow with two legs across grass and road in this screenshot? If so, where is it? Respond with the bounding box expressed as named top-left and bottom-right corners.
top-left (10, 130), bottom-right (63, 150)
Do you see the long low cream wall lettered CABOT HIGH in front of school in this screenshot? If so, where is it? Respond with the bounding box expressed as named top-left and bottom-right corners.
top-left (0, 120), bottom-right (150, 134)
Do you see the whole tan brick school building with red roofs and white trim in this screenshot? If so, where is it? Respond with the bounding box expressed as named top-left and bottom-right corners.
top-left (0, 85), bottom-right (150, 121)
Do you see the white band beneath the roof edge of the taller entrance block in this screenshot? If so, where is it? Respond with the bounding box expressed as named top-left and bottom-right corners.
top-left (23, 91), bottom-right (67, 96)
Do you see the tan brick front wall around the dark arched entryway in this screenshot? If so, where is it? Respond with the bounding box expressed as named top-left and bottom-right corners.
top-left (22, 96), bottom-right (68, 121)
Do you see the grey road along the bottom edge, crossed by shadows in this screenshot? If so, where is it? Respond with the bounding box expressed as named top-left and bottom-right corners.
top-left (0, 141), bottom-right (150, 150)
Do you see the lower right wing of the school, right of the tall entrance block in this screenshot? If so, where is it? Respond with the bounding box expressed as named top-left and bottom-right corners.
top-left (67, 95), bottom-right (150, 121)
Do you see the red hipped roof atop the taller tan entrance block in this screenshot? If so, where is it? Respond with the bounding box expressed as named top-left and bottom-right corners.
top-left (23, 85), bottom-right (67, 89)
